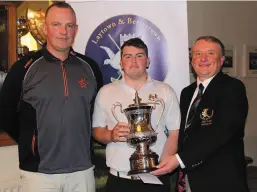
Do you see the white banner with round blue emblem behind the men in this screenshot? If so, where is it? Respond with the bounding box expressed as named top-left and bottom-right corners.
top-left (67, 0), bottom-right (189, 97)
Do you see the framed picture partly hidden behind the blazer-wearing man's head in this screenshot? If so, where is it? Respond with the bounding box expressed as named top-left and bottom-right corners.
top-left (222, 45), bottom-right (236, 76)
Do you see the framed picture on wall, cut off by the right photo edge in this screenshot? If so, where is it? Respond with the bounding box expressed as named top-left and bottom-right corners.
top-left (243, 44), bottom-right (257, 78)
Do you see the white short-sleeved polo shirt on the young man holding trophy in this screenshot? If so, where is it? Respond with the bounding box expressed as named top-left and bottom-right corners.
top-left (93, 76), bottom-right (180, 172)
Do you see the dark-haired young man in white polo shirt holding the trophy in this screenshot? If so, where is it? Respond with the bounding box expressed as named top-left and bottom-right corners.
top-left (93, 38), bottom-right (180, 192)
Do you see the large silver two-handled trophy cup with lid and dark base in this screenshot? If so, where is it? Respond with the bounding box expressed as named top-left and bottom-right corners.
top-left (112, 92), bottom-right (164, 175)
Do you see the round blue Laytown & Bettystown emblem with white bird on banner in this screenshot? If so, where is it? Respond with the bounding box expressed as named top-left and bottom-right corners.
top-left (85, 15), bottom-right (168, 84)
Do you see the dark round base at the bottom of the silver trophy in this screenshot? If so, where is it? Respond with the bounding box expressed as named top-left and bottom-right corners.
top-left (128, 151), bottom-right (159, 175)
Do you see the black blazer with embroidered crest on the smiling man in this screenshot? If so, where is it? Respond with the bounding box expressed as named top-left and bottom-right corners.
top-left (178, 72), bottom-right (249, 192)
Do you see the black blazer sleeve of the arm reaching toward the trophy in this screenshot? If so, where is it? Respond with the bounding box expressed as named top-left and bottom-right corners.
top-left (178, 81), bottom-right (248, 169)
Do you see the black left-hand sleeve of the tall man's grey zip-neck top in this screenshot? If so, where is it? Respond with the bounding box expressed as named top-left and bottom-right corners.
top-left (0, 61), bottom-right (24, 142)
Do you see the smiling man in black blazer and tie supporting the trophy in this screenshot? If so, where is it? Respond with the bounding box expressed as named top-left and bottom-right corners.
top-left (152, 36), bottom-right (249, 192)
